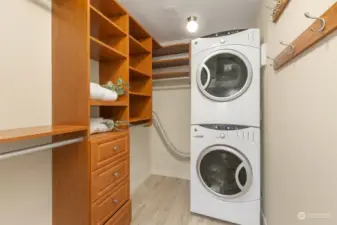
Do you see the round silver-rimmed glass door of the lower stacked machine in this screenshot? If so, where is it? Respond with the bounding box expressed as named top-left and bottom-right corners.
top-left (197, 146), bottom-right (253, 199)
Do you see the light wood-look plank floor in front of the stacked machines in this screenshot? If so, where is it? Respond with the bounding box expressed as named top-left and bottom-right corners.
top-left (132, 175), bottom-right (231, 225)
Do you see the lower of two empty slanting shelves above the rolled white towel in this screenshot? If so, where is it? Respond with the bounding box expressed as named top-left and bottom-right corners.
top-left (90, 37), bottom-right (127, 61)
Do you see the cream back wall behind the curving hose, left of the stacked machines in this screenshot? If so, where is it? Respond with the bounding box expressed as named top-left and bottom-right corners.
top-left (151, 82), bottom-right (191, 179)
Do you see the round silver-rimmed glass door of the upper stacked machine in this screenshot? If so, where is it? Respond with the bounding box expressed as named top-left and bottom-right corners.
top-left (197, 50), bottom-right (253, 102)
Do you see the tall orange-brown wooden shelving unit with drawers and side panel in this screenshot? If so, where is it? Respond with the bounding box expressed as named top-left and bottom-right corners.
top-left (52, 0), bottom-right (160, 225)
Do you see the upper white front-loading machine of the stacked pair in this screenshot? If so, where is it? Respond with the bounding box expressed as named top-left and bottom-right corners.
top-left (191, 29), bottom-right (261, 127)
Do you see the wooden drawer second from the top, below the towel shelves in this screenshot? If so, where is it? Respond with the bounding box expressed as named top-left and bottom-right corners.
top-left (91, 155), bottom-right (130, 202)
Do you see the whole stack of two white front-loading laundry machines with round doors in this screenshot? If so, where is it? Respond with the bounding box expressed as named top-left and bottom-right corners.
top-left (191, 29), bottom-right (261, 225)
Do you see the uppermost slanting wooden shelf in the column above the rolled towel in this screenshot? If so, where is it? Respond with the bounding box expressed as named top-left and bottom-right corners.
top-left (90, 6), bottom-right (127, 39)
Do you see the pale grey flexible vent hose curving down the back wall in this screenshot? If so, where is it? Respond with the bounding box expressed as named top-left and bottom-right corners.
top-left (152, 111), bottom-right (190, 159)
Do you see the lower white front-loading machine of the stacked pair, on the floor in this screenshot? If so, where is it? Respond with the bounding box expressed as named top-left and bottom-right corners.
top-left (191, 124), bottom-right (261, 225)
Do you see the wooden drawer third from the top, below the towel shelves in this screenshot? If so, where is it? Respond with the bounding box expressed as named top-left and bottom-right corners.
top-left (91, 180), bottom-right (130, 225)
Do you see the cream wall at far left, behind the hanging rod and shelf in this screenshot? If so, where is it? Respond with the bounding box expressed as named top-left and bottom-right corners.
top-left (0, 0), bottom-right (52, 225)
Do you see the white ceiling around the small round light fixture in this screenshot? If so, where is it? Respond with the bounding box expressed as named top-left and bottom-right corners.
top-left (120, 0), bottom-right (260, 43)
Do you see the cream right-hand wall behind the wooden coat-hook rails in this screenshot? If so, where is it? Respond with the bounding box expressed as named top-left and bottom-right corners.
top-left (260, 0), bottom-right (337, 225)
